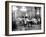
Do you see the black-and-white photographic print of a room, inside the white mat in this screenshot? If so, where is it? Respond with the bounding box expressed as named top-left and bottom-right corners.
top-left (12, 5), bottom-right (41, 31)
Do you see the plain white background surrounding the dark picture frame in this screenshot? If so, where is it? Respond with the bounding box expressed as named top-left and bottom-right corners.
top-left (0, 0), bottom-right (46, 37)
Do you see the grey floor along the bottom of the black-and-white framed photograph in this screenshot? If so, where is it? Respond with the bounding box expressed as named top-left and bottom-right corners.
top-left (13, 25), bottom-right (41, 31)
